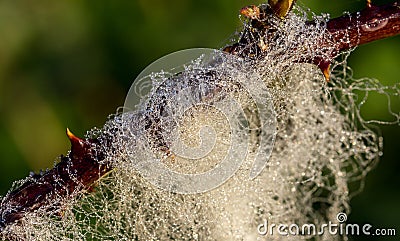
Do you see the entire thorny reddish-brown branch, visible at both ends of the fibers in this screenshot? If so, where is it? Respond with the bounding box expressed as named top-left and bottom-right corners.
top-left (0, 1), bottom-right (400, 239)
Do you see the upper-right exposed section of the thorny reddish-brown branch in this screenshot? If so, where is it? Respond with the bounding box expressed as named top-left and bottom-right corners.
top-left (224, 1), bottom-right (400, 80)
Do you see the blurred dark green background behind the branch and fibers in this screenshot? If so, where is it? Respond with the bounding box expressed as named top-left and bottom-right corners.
top-left (0, 0), bottom-right (400, 240)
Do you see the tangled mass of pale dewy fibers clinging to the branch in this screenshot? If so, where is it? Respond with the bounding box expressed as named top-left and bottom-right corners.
top-left (1, 4), bottom-right (399, 240)
